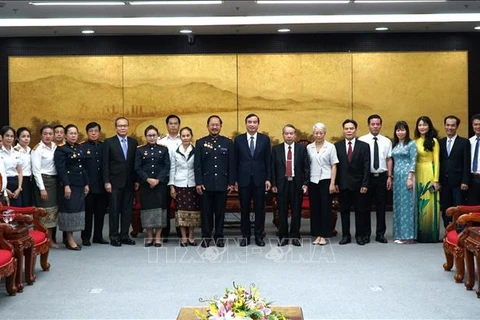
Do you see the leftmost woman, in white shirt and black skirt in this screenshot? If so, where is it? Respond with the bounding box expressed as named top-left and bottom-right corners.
top-left (0, 126), bottom-right (23, 207)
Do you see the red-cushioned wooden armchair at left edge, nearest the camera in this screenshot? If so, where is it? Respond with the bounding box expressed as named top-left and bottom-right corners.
top-left (0, 223), bottom-right (17, 296)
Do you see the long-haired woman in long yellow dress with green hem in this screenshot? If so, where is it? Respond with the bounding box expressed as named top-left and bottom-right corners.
top-left (415, 116), bottom-right (440, 242)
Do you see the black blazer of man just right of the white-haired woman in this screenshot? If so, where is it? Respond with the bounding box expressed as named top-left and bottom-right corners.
top-left (335, 139), bottom-right (370, 191)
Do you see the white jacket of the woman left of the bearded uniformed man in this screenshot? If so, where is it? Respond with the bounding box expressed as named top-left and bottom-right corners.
top-left (168, 145), bottom-right (195, 188)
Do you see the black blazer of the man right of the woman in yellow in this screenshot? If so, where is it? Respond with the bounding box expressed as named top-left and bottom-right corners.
top-left (439, 136), bottom-right (470, 187)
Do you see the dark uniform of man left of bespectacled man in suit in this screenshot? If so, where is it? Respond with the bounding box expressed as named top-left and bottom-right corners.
top-left (81, 140), bottom-right (108, 245)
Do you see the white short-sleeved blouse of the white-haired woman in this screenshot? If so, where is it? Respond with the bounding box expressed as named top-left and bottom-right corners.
top-left (307, 141), bottom-right (338, 184)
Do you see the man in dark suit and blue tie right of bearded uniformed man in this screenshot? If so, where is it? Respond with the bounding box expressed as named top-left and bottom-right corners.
top-left (234, 113), bottom-right (271, 247)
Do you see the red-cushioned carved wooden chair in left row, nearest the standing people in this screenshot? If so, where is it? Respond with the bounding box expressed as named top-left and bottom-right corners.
top-left (0, 206), bottom-right (50, 271)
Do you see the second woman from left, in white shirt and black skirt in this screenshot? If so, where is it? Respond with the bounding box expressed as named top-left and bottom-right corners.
top-left (15, 127), bottom-right (33, 207)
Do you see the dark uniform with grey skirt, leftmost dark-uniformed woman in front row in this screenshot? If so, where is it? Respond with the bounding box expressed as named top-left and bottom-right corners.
top-left (53, 143), bottom-right (88, 232)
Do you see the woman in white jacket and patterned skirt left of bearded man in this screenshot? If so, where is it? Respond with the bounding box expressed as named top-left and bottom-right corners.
top-left (168, 127), bottom-right (201, 247)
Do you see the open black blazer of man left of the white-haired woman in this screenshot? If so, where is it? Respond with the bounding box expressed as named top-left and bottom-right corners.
top-left (271, 142), bottom-right (310, 193)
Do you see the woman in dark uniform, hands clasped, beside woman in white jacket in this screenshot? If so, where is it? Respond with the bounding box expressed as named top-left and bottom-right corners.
top-left (135, 125), bottom-right (170, 247)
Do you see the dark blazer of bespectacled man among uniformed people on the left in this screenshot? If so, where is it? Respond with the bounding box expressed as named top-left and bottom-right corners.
top-left (102, 135), bottom-right (138, 189)
